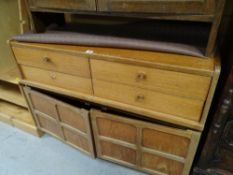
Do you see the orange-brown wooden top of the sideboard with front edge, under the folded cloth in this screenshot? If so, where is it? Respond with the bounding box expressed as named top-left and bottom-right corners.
top-left (11, 41), bottom-right (215, 76)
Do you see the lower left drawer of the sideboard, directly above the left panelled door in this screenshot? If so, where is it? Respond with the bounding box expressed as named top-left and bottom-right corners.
top-left (20, 66), bottom-right (93, 94)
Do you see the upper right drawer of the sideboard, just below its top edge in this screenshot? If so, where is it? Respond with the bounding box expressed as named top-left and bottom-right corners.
top-left (91, 59), bottom-right (211, 100)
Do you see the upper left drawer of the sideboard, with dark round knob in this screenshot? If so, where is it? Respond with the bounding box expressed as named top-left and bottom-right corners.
top-left (12, 46), bottom-right (90, 78)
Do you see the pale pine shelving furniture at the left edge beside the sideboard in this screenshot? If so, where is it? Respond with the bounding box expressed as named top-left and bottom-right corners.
top-left (0, 0), bottom-right (40, 136)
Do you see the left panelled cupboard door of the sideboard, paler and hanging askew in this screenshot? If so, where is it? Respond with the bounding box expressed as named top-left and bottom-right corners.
top-left (23, 87), bottom-right (94, 157)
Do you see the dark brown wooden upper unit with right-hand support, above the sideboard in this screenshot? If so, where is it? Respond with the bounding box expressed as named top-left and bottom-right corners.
top-left (27, 0), bottom-right (225, 57)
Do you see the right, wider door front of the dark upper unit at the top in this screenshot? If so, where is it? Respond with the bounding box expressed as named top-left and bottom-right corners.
top-left (98, 0), bottom-right (216, 14)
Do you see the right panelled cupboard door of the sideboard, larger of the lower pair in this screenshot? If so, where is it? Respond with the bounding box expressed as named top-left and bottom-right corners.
top-left (91, 110), bottom-right (200, 175)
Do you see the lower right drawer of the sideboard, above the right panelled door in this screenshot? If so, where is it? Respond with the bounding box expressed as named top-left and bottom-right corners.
top-left (93, 80), bottom-right (204, 121)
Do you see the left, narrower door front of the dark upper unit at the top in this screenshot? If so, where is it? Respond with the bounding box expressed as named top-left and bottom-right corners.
top-left (28, 0), bottom-right (96, 11)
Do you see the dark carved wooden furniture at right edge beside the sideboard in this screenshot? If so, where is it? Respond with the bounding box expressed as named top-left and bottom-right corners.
top-left (192, 66), bottom-right (233, 175)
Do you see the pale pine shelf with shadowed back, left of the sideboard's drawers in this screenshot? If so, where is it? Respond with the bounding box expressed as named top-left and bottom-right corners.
top-left (0, 81), bottom-right (27, 108)
